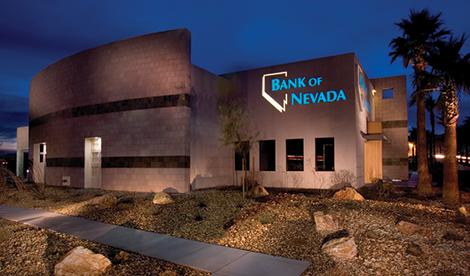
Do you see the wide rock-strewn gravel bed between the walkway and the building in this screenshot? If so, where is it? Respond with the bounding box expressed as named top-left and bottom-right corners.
top-left (0, 188), bottom-right (470, 275)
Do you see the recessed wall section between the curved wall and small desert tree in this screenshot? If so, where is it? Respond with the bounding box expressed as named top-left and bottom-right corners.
top-left (190, 67), bottom-right (234, 189)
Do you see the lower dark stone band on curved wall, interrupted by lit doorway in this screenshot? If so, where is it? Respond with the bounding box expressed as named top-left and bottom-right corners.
top-left (46, 155), bottom-right (190, 168)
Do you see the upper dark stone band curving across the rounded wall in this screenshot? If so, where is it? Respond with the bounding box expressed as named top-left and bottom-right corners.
top-left (29, 94), bottom-right (189, 127)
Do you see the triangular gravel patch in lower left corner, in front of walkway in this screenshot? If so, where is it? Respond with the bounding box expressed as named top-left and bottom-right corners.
top-left (0, 219), bottom-right (207, 275)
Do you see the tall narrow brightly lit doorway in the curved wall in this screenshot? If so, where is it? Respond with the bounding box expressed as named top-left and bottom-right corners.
top-left (84, 137), bottom-right (101, 188)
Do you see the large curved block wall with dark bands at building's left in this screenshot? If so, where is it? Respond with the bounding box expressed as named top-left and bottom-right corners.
top-left (30, 30), bottom-right (191, 192)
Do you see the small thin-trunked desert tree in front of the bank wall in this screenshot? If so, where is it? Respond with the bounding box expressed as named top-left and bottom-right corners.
top-left (218, 93), bottom-right (258, 197)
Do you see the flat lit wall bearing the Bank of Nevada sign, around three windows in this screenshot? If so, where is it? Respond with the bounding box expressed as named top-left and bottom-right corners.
top-left (225, 54), bottom-right (357, 188)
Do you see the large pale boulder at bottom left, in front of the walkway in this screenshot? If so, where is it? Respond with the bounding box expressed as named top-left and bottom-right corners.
top-left (54, 246), bottom-right (111, 276)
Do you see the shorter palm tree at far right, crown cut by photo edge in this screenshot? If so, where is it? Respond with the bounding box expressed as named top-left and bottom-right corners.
top-left (429, 35), bottom-right (470, 205)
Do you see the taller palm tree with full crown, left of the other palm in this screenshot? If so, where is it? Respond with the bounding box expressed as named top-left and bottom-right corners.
top-left (389, 9), bottom-right (450, 196)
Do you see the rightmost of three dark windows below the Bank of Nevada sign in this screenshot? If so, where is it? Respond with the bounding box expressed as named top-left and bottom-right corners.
top-left (315, 138), bottom-right (335, 171)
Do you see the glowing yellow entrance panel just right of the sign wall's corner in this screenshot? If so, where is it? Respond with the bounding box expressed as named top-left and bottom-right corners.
top-left (364, 140), bottom-right (383, 183)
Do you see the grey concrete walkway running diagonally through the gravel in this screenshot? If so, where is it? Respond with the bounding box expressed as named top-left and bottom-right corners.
top-left (0, 205), bottom-right (310, 276)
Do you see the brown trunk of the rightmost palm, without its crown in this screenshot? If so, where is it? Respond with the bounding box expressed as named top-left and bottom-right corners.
top-left (442, 89), bottom-right (460, 206)
